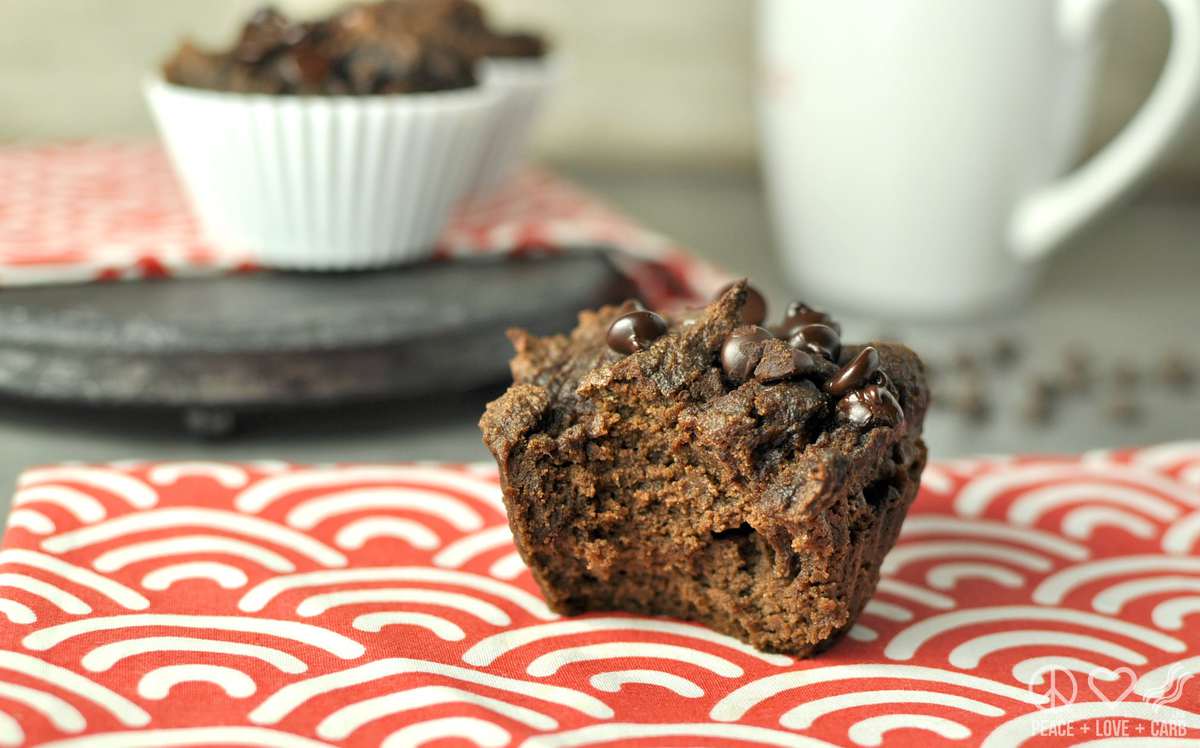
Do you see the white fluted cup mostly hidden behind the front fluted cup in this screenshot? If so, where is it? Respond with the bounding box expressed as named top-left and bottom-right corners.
top-left (472, 56), bottom-right (562, 197)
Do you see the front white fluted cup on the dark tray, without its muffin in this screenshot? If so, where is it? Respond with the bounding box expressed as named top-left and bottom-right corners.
top-left (145, 78), bottom-right (499, 270)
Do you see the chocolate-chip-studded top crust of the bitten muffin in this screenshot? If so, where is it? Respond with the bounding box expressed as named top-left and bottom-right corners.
top-left (481, 282), bottom-right (929, 485)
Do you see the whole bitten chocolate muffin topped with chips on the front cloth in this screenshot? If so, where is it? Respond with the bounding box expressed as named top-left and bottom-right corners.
top-left (480, 282), bottom-right (929, 656)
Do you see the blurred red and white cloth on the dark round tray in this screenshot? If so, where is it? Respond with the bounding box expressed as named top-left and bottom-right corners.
top-left (0, 142), bottom-right (722, 306)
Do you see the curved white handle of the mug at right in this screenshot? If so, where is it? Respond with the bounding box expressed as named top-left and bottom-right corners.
top-left (1009, 0), bottom-right (1200, 259)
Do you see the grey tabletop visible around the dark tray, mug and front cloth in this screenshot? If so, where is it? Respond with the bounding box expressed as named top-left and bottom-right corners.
top-left (0, 170), bottom-right (1200, 516)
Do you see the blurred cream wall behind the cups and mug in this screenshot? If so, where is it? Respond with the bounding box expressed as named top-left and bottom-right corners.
top-left (0, 0), bottom-right (1200, 182)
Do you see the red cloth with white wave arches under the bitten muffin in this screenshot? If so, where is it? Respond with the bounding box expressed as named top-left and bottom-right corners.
top-left (0, 442), bottom-right (1200, 748)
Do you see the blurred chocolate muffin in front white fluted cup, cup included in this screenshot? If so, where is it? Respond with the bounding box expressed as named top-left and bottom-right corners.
top-left (145, 0), bottom-right (504, 271)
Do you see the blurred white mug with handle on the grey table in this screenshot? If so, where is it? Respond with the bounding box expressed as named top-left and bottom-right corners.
top-left (758, 0), bottom-right (1200, 317)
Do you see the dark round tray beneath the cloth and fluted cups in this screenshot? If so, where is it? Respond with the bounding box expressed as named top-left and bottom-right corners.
top-left (0, 250), bottom-right (635, 432)
